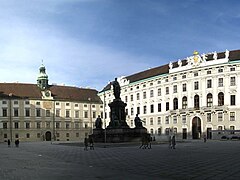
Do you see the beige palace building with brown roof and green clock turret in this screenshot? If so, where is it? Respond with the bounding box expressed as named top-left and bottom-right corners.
top-left (0, 65), bottom-right (103, 142)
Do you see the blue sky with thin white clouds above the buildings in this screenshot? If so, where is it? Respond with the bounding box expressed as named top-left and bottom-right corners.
top-left (0, 0), bottom-right (240, 90)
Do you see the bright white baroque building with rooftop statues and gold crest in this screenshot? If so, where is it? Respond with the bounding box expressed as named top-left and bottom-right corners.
top-left (99, 50), bottom-right (240, 139)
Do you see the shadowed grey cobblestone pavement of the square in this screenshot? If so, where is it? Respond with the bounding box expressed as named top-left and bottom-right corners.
top-left (0, 141), bottom-right (240, 180)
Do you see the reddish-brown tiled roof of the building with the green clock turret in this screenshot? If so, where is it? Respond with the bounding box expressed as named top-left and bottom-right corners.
top-left (0, 83), bottom-right (102, 103)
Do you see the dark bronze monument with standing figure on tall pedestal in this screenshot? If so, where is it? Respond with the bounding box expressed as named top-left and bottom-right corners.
top-left (92, 78), bottom-right (148, 143)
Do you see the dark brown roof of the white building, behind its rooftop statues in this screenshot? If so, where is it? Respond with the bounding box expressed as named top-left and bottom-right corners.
top-left (101, 50), bottom-right (240, 92)
